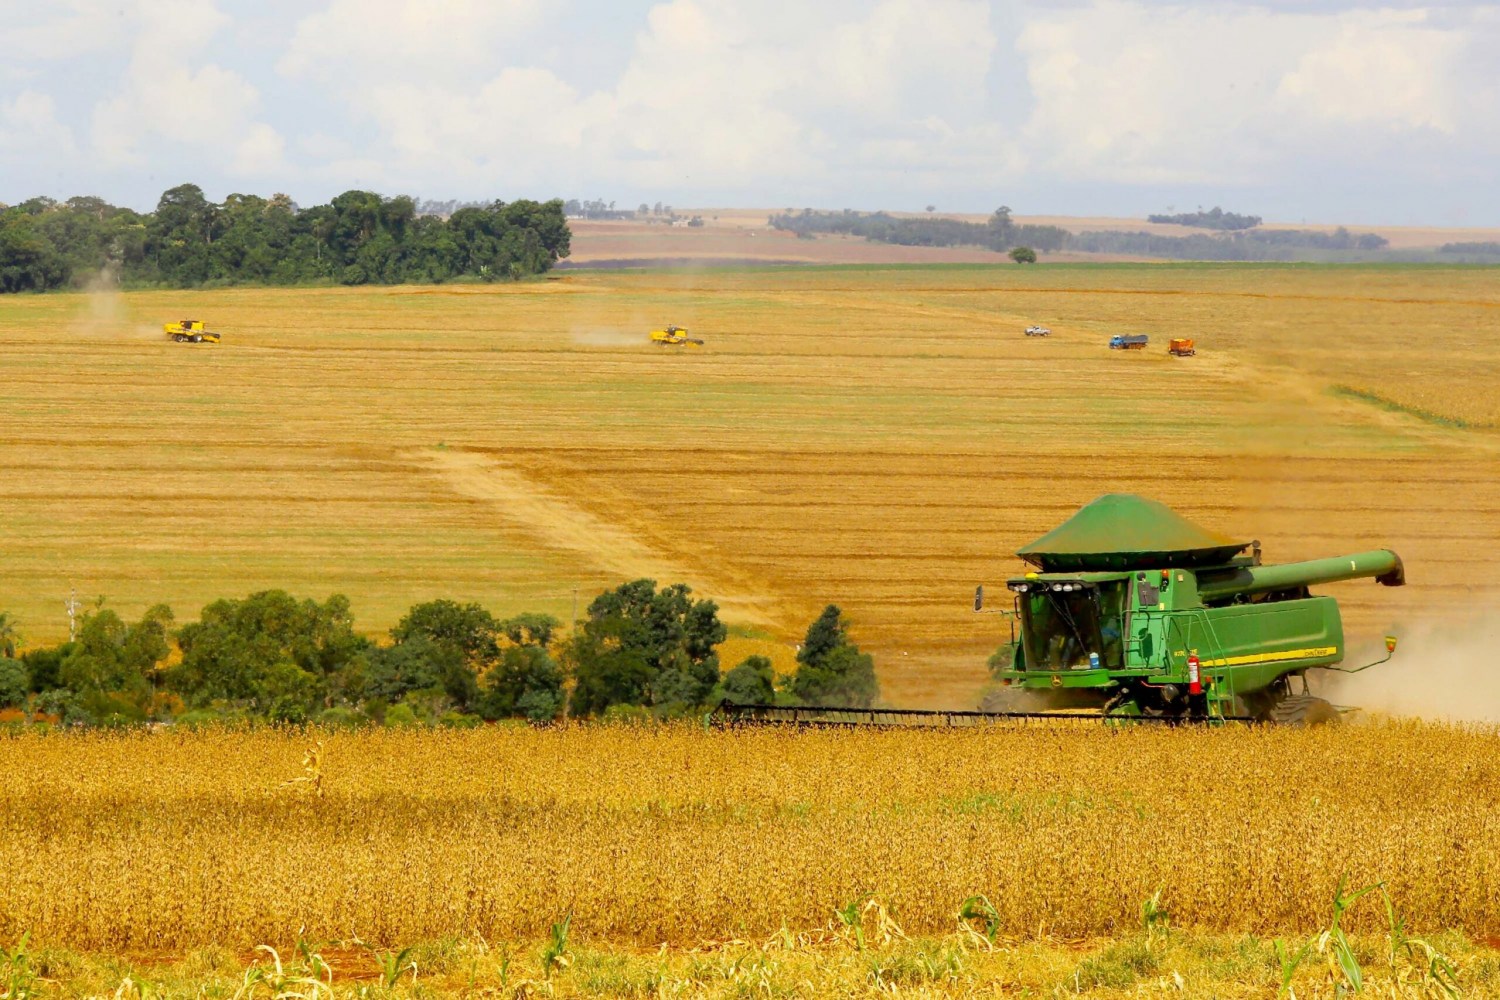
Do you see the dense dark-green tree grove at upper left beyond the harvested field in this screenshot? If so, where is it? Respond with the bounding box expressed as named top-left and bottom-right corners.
top-left (0, 184), bottom-right (572, 292)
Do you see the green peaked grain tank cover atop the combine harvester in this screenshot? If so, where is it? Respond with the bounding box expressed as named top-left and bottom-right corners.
top-left (1016, 493), bottom-right (1250, 573)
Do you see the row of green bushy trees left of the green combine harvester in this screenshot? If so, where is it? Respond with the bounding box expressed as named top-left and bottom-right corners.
top-left (0, 580), bottom-right (879, 726)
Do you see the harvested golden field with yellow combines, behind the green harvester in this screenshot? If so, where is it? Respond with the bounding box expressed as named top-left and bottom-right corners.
top-left (0, 265), bottom-right (1500, 708)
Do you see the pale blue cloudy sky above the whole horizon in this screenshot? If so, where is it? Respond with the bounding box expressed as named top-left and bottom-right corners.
top-left (0, 0), bottom-right (1500, 226)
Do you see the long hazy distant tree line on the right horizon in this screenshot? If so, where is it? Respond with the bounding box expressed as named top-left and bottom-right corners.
top-left (770, 205), bottom-right (1391, 262)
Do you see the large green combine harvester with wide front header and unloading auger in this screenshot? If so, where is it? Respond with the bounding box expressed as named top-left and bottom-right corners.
top-left (722, 493), bottom-right (1406, 726)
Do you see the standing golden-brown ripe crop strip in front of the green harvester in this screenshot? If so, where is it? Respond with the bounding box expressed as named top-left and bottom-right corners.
top-left (0, 723), bottom-right (1500, 954)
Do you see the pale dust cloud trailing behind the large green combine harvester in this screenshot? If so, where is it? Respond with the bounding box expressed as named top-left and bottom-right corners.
top-left (1314, 615), bottom-right (1500, 723)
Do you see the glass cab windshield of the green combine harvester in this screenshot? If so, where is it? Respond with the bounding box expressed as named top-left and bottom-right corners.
top-left (1020, 583), bottom-right (1124, 670)
